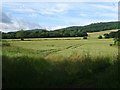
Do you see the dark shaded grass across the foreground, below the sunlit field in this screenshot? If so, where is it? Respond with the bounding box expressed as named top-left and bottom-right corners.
top-left (2, 55), bottom-right (120, 89)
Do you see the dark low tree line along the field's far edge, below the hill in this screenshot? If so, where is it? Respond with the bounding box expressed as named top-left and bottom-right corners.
top-left (2, 30), bottom-right (88, 39)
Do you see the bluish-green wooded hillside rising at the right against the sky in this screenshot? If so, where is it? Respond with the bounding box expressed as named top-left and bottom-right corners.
top-left (57, 22), bottom-right (119, 32)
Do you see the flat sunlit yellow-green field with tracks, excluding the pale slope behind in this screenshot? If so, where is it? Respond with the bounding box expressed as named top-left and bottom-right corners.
top-left (3, 39), bottom-right (117, 56)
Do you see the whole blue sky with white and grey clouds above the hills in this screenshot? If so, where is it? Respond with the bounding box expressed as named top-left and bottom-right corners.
top-left (0, 1), bottom-right (118, 32)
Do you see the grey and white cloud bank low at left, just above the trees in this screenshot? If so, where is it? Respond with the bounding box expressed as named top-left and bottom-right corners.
top-left (0, 13), bottom-right (42, 32)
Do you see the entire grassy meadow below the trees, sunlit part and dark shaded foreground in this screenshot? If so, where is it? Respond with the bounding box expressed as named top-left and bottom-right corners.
top-left (2, 31), bottom-right (120, 88)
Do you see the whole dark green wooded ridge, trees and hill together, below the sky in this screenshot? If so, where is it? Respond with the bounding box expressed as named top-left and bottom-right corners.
top-left (2, 22), bottom-right (119, 39)
